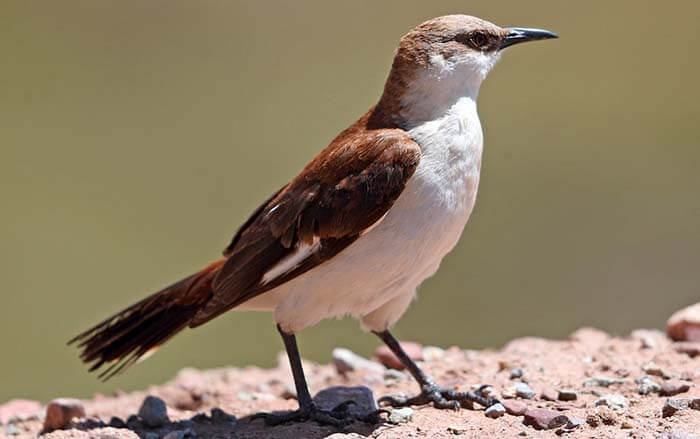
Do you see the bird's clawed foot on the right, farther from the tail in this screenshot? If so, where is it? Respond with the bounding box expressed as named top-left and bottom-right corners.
top-left (379, 383), bottom-right (499, 410)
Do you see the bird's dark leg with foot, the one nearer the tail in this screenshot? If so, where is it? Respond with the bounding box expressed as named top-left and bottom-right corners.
top-left (251, 325), bottom-right (378, 427)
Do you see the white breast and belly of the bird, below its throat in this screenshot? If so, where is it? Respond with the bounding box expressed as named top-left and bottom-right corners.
top-left (237, 97), bottom-right (482, 332)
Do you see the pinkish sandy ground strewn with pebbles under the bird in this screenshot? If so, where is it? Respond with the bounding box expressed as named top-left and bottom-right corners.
top-left (0, 329), bottom-right (700, 439)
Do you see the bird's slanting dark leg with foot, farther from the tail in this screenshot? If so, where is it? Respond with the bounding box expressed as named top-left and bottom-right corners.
top-left (374, 330), bottom-right (498, 410)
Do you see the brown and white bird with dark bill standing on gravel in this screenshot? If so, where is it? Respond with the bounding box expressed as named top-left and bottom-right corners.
top-left (69, 14), bottom-right (558, 426)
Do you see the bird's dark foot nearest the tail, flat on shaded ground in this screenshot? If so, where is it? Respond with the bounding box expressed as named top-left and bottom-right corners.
top-left (251, 401), bottom-right (386, 428)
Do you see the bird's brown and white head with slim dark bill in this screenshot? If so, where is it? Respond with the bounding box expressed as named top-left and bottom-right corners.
top-left (384, 15), bottom-right (557, 127)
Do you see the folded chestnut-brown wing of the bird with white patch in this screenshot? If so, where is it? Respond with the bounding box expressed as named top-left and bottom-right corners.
top-left (190, 119), bottom-right (420, 327)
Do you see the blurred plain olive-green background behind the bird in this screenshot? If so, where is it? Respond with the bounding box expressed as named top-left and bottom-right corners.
top-left (0, 0), bottom-right (700, 401)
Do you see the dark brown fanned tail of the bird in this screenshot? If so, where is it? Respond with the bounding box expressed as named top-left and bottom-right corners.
top-left (68, 259), bottom-right (225, 380)
